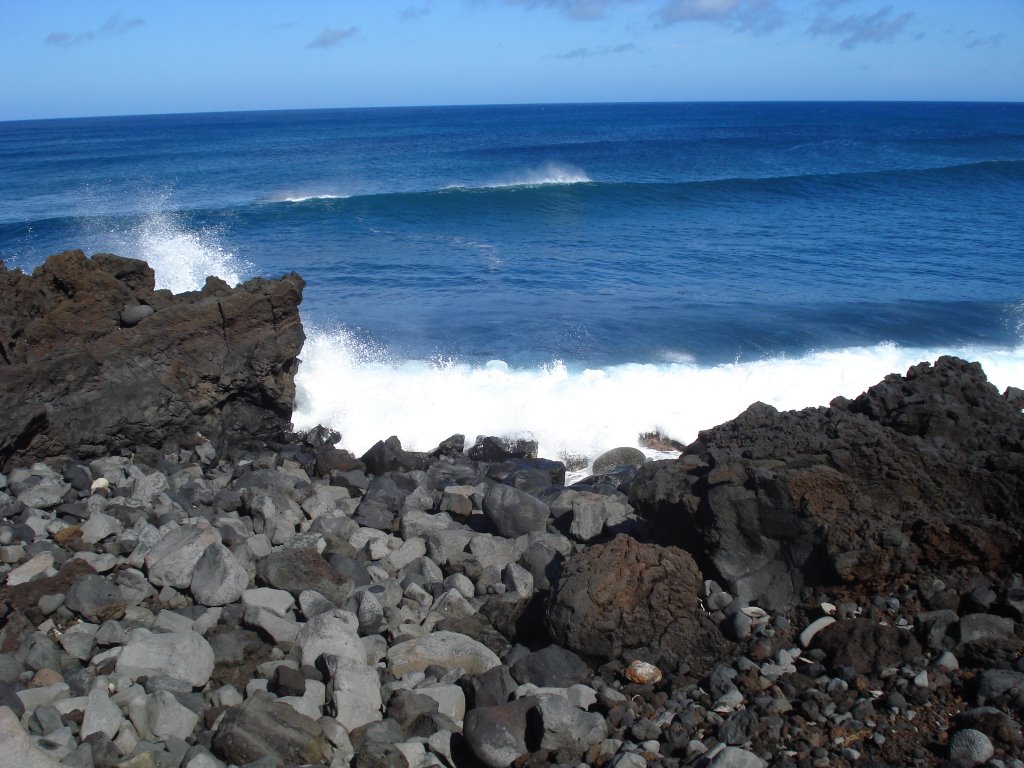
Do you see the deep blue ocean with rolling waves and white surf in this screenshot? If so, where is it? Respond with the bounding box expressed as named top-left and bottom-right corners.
top-left (0, 102), bottom-right (1024, 458)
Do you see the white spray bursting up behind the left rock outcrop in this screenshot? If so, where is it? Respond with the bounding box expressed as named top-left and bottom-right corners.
top-left (106, 212), bottom-right (253, 293)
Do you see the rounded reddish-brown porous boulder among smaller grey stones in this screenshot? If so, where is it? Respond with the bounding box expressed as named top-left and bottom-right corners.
top-left (546, 535), bottom-right (728, 669)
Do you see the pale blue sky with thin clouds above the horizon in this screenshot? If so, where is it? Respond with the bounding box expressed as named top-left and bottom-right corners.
top-left (0, 0), bottom-right (1024, 120)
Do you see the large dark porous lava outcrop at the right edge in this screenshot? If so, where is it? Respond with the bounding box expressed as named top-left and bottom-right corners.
top-left (631, 356), bottom-right (1024, 608)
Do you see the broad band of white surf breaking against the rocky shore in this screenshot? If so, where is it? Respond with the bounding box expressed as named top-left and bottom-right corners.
top-left (294, 331), bottom-right (1024, 466)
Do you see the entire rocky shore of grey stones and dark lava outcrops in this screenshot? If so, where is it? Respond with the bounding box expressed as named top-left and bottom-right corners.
top-left (0, 252), bottom-right (1024, 768)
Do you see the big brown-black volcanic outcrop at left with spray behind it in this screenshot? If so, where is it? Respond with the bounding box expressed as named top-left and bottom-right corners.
top-left (0, 251), bottom-right (305, 467)
